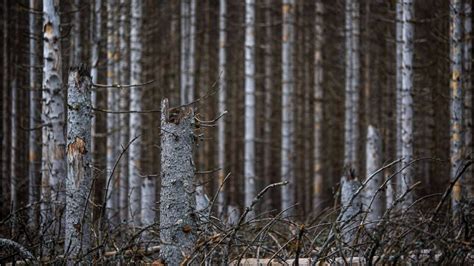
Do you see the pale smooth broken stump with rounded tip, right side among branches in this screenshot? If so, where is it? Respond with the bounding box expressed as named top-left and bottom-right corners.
top-left (363, 125), bottom-right (385, 228)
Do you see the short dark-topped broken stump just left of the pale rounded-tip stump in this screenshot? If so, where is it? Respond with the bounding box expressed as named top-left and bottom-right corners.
top-left (339, 169), bottom-right (362, 243)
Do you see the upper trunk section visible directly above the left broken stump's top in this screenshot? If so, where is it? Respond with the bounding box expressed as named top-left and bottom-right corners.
top-left (69, 0), bottom-right (83, 67)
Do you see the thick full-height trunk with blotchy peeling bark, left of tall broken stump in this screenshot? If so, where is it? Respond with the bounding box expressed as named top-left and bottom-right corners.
top-left (41, 0), bottom-right (66, 251)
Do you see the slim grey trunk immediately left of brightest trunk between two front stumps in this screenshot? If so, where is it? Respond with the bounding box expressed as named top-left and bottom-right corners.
top-left (119, 0), bottom-right (130, 222)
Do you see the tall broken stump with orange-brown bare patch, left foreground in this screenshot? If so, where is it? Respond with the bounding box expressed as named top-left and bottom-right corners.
top-left (64, 67), bottom-right (92, 264)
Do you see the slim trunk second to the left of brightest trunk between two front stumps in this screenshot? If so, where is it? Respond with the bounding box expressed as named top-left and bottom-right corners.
top-left (106, 0), bottom-right (119, 225)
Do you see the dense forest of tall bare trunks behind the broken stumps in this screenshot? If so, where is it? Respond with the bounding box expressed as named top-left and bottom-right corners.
top-left (0, 0), bottom-right (474, 262)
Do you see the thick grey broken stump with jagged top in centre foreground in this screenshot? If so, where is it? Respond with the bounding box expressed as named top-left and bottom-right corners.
top-left (160, 99), bottom-right (197, 265)
